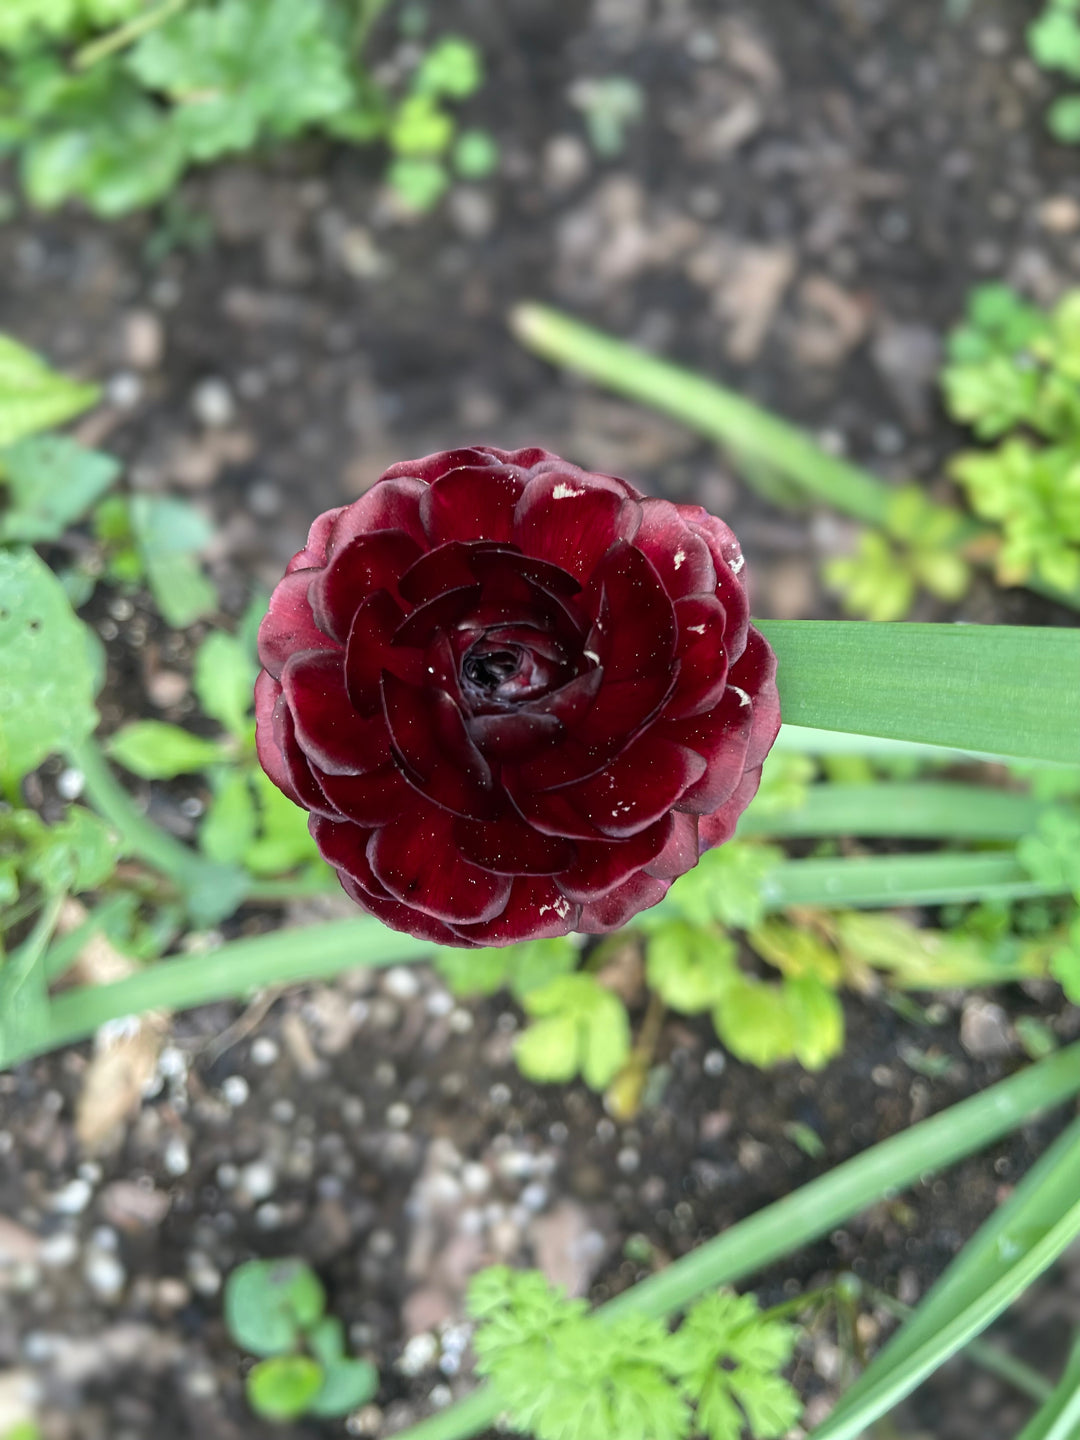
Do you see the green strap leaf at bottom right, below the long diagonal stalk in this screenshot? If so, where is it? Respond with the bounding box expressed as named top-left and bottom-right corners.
top-left (812, 1120), bottom-right (1080, 1440)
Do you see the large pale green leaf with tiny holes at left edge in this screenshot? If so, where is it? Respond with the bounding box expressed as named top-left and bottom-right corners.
top-left (0, 550), bottom-right (98, 791)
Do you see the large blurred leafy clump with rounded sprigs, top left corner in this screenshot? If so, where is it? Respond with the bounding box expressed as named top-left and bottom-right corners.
top-left (0, 0), bottom-right (494, 216)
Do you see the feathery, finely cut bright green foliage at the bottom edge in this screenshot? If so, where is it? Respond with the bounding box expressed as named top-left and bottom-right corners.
top-left (468, 1266), bottom-right (801, 1440)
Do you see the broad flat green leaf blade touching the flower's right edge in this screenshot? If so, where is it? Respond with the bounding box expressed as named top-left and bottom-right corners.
top-left (759, 621), bottom-right (1080, 765)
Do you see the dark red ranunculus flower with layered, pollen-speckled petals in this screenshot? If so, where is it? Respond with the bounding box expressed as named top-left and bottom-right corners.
top-left (255, 446), bottom-right (780, 945)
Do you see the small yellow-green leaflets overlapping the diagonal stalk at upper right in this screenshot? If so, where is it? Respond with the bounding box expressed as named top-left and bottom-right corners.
top-left (825, 485), bottom-right (971, 621)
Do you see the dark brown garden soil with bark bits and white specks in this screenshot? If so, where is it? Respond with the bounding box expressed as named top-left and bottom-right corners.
top-left (0, 0), bottom-right (1080, 1440)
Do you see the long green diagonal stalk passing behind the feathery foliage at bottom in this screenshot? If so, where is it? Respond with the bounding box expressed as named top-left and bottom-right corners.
top-left (397, 1045), bottom-right (1080, 1440)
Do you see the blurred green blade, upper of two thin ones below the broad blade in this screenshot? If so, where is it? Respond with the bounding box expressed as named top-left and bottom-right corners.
top-left (739, 782), bottom-right (1047, 840)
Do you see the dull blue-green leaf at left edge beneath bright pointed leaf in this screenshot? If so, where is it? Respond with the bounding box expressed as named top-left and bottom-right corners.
top-left (0, 435), bottom-right (120, 544)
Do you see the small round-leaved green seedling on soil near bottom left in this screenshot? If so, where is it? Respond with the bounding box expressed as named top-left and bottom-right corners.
top-left (225, 1260), bottom-right (379, 1421)
